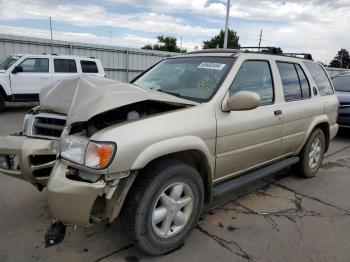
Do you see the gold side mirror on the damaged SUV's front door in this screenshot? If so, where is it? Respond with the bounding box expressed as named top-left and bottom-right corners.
top-left (223, 91), bottom-right (260, 111)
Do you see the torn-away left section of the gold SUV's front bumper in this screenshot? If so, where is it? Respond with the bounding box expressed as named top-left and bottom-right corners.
top-left (0, 135), bottom-right (58, 189)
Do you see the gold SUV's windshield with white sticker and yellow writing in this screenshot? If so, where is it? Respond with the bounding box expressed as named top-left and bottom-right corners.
top-left (133, 57), bottom-right (234, 102)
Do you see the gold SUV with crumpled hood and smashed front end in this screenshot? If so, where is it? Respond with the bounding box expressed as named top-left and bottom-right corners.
top-left (0, 49), bottom-right (339, 255)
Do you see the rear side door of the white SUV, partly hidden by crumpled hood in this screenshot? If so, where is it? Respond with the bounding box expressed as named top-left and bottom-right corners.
top-left (52, 58), bottom-right (78, 83)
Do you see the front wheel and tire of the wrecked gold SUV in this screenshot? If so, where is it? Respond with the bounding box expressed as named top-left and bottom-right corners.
top-left (121, 160), bottom-right (204, 255)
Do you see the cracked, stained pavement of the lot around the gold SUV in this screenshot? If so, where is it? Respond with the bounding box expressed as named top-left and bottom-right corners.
top-left (0, 105), bottom-right (350, 262)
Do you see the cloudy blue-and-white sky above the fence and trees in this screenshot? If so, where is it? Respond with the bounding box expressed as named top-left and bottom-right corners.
top-left (0, 0), bottom-right (350, 63)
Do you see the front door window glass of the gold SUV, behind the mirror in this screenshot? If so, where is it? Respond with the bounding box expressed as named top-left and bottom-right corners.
top-left (229, 61), bottom-right (274, 106)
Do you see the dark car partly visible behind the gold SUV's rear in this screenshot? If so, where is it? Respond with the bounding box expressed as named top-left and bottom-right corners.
top-left (333, 73), bottom-right (350, 128)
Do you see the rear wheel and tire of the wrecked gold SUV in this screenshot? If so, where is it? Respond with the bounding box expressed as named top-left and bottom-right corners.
top-left (296, 128), bottom-right (326, 178)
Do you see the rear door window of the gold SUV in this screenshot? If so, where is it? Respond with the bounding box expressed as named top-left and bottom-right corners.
top-left (277, 62), bottom-right (302, 101)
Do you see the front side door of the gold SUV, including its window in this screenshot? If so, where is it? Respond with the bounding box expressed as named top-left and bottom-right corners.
top-left (215, 60), bottom-right (282, 181)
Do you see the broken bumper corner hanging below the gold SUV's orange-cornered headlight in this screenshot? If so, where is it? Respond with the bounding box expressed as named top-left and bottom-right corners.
top-left (47, 159), bottom-right (136, 225)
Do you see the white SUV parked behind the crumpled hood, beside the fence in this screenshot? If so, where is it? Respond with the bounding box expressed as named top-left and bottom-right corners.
top-left (0, 54), bottom-right (105, 111)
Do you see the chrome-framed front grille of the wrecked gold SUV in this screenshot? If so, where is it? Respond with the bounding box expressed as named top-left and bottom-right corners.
top-left (24, 113), bottom-right (66, 139)
